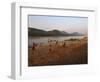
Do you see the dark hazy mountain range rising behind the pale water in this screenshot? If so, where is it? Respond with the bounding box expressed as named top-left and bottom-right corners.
top-left (28, 27), bottom-right (83, 36)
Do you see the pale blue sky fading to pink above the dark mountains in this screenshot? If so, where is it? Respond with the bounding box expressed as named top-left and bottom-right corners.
top-left (28, 15), bottom-right (88, 34)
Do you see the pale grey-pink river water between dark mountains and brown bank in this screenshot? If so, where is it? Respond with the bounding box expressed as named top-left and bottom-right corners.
top-left (28, 36), bottom-right (84, 47)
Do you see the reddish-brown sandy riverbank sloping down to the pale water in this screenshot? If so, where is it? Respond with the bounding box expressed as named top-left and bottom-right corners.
top-left (28, 38), bottom-right (88, 66)
